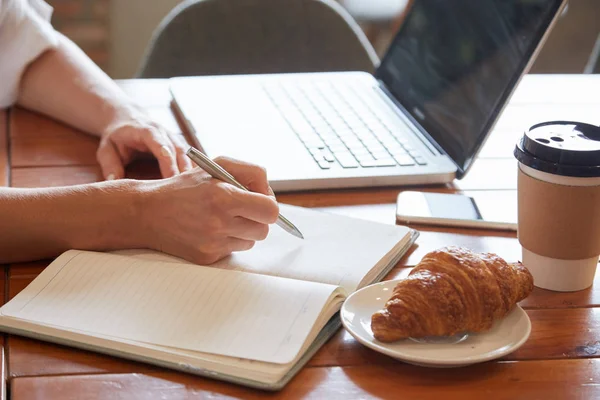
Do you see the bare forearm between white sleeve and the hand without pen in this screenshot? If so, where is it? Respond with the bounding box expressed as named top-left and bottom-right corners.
top-left (18, 31), bottom-right (138, 135)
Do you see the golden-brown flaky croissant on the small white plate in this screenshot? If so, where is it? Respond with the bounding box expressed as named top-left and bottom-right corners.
top-left (371, 247), bottom-right (533, 342)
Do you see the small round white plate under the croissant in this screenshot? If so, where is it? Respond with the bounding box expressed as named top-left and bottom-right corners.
top-left (341, 280), bottom-right (531, 367)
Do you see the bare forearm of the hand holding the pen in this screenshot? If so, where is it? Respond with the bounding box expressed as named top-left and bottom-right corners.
top-left (0, 180), bottom-right (144, 263)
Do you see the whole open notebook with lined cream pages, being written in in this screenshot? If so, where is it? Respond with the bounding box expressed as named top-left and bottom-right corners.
top-left (0, 206), bottom-right (417, 390)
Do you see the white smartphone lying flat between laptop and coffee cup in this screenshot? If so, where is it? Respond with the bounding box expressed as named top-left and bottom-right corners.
top-left (396, 191), bottom-right (517, 231)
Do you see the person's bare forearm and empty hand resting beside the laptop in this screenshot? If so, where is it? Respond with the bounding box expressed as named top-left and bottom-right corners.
top-left (16, 32), bottom-right (191, 180)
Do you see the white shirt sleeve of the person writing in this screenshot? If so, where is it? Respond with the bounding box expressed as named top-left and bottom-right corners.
top-left (0, 0), bottom-right (58, 109)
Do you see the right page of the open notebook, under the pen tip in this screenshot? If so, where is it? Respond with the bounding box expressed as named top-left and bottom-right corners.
top-left (213, 204), bottom-right (410, 293)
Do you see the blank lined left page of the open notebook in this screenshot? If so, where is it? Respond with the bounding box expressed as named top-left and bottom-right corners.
top-left (2, 250), bottom-right (336, 363)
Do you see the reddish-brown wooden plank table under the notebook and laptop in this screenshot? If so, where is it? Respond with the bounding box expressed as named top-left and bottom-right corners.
top-left (0, 75), bottom-right (600, 400)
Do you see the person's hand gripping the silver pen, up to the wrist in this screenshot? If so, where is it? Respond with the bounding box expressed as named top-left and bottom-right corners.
top-left (142, 158), bottom-right (279, 264)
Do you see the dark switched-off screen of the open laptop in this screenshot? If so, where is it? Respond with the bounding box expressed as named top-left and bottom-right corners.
top-left (376, 0), bottom-right (562, 177)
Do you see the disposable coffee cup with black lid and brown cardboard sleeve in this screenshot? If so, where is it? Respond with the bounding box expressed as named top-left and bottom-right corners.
top-left (514, 121), bottom-right (600, 292)
